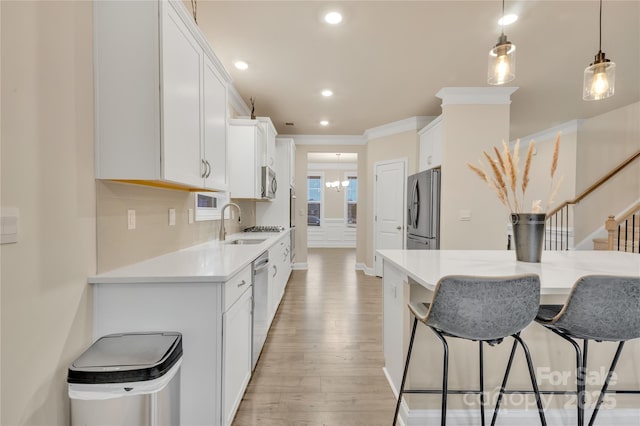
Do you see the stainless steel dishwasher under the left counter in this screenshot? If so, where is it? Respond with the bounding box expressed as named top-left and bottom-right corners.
top-left (251, 251), bottom-right (269, 371)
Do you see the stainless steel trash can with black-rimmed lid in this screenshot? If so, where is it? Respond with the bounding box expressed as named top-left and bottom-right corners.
top-left (67, 332), bottom-right (182, 426)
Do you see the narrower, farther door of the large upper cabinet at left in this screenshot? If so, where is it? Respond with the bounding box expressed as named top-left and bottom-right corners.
top-left (202, 56), bottom-right (228, 191)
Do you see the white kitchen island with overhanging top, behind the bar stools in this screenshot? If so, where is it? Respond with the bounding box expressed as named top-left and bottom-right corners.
top-left (377, 250), bottom-right (640, 425)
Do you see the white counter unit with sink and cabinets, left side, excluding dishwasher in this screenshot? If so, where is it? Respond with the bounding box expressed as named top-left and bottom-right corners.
top-left (88, 231), bottom-right (291, 425)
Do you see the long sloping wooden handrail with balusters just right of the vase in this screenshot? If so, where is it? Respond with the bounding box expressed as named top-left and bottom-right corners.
top-left (544, 151), bottom-right (640, 250)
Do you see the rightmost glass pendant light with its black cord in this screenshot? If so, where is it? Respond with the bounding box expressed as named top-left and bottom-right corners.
top-left (582, 0), bottom-right (616, 101)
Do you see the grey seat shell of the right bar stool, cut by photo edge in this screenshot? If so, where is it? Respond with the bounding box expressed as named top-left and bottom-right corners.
top-left (551, 275), bottom-right (640, 341)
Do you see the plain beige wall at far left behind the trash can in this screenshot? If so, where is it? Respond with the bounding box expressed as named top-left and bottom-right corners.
top-left (0, 1), bottom-right (96, 425)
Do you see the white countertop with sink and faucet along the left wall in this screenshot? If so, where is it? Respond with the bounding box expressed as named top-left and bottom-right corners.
top-left (88, 230), bottom-right (289, 284)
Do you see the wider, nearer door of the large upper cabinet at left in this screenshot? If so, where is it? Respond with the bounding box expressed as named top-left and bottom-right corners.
top-left (161, 2), bottom-right (204, 187)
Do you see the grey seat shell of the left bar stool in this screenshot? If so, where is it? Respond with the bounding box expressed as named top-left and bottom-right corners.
top-left (424, 274), bottom-right (540, 340)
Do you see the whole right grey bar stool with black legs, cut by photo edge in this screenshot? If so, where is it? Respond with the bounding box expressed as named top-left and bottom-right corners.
top-left (536, 275), bottom-right (640, 426)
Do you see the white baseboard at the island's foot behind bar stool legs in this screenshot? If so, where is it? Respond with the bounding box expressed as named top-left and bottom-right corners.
top-left (400, 403), bottom-right (640, 426)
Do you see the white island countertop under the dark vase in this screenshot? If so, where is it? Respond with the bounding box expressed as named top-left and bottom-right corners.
top-left (378, 250), bottom-right (640, 294)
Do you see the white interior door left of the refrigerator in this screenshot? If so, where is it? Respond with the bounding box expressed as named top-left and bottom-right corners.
top-left (373, 160), bottom-right (407, 277)
